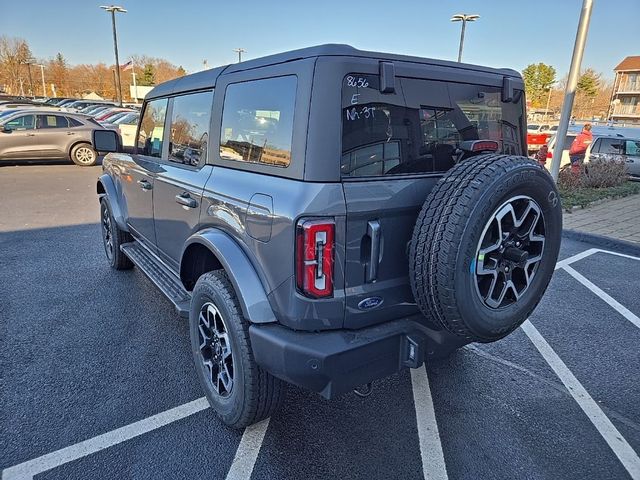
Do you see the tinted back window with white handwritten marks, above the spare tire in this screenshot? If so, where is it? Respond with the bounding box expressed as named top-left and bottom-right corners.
top-left (341, 74), bottom-right (525, 177)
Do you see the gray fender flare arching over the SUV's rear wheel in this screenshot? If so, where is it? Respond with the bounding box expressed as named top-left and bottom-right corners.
top-left (180, 228), bottom-right (277, 323)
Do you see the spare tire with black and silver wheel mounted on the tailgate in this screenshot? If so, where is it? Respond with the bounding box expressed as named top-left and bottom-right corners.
top-left (409, 154), bottom-right (562, 342)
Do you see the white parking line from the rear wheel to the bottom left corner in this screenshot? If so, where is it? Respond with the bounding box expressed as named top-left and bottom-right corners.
top-left (2, 397), bottom-right (209, 480)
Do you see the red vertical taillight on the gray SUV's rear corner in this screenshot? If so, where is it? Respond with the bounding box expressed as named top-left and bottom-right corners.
top-left (296, 219), bottom-right (335, 298)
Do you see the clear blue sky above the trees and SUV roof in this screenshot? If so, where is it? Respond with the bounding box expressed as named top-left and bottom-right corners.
top-left (0, 0), bottom-right (640, 78)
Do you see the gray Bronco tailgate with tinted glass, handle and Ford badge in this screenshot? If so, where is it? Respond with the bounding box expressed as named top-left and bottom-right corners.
top-left (341, 73), bottom-right (526, 328)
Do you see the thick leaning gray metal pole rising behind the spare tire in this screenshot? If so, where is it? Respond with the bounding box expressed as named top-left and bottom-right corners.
top-left (551, 0), bottom-right (593, 181)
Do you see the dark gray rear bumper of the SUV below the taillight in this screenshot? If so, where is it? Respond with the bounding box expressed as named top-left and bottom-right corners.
top-left (249, 316), bottom-right (468, 399)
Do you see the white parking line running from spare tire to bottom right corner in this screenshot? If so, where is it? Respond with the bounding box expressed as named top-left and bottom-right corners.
top-left (522, 320), bottom-right (640, 480)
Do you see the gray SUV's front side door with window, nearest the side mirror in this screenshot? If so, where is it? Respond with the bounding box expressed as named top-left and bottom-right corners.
top-left (122, 98), bottom-right (168, 246)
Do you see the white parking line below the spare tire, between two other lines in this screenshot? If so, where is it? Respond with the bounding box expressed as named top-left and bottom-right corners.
top-left (411, 366), bottom-right (449, 480)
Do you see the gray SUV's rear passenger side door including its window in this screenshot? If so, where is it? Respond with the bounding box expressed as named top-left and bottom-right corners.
top-left (153, 90), bottom-right (213, 269)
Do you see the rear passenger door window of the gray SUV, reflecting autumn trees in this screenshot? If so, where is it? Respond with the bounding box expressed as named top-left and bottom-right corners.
top-left (169, 92), bottom-right (213, 167)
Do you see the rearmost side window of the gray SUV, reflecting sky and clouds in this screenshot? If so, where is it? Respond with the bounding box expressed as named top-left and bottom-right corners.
top-left (220, 76), bottom-right (297, 167)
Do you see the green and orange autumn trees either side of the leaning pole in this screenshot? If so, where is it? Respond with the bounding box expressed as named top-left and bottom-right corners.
top-left (522, 63), bottom-right (613, 120)
